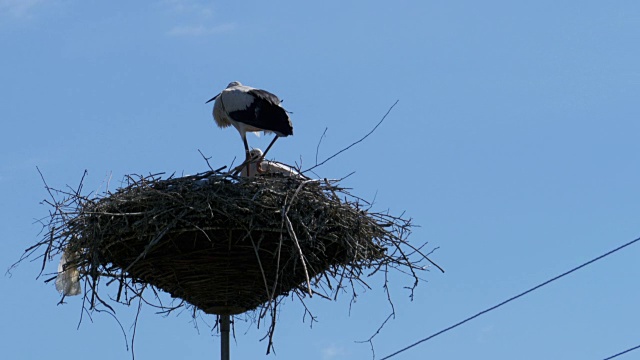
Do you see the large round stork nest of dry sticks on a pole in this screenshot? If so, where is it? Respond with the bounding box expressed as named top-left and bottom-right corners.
top-left (25, 171), bottom-right (440, 352)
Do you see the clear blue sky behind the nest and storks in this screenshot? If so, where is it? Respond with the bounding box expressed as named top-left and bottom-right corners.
top-left (0, 0), bottom-right (640, 360)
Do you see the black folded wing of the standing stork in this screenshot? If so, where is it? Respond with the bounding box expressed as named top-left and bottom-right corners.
top-left (229, 89), bottom-right (293, 137)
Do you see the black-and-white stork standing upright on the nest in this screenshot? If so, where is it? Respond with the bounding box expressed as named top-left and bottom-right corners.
top-left (207, 81), bottom-right (293, 173)
